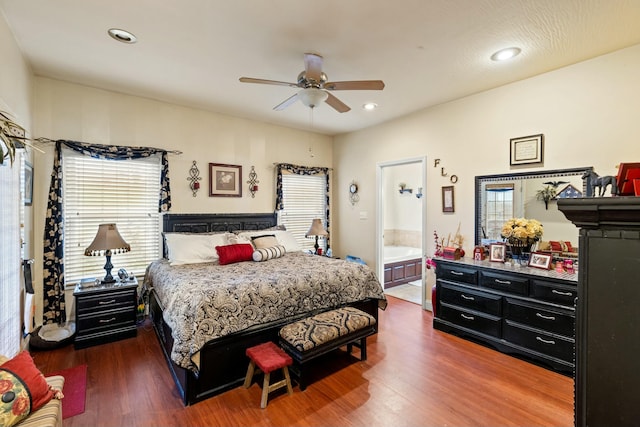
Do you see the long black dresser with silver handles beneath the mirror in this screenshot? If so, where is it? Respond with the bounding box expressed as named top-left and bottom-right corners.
top-left (433, 258), bottom-right (578, 375)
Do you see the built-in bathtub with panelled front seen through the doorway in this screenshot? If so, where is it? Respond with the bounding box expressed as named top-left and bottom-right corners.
top-left (383, 246), bottom-right (422, 288)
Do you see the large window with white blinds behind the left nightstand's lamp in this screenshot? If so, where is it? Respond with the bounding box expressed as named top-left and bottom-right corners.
top-left (62, 148), bottom-right (161, 285)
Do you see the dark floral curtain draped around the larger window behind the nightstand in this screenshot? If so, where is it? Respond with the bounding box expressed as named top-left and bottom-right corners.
top-left (43, 140), bottom-right (171, 324)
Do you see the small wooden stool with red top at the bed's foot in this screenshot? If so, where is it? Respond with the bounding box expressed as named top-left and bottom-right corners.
top-left (244, 341), bottom-right (293, 409)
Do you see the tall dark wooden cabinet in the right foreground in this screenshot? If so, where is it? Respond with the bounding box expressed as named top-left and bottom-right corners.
top-left (558, 197), bottom-right (640, 426)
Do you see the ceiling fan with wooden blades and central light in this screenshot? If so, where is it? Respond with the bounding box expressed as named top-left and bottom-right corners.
top-left (240, 53), bottom-right (384, 113)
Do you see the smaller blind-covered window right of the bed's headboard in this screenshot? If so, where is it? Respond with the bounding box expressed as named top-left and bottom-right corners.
top-left (280, 172), bottom-right (327, 250)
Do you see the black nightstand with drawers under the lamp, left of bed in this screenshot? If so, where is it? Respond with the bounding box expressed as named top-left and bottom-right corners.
top-left (73, 277), bottom-right (138, 349)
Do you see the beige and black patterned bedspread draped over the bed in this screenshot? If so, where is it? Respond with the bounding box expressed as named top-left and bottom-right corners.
top-left (145, 252), bottom-right (386, 369)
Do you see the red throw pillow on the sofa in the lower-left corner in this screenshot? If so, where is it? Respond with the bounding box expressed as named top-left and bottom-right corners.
top-left (0, 351), bottom-right (53, 418)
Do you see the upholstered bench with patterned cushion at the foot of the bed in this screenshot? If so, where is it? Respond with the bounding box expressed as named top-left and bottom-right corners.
top-left (279, 307), bottom-right (376, 390)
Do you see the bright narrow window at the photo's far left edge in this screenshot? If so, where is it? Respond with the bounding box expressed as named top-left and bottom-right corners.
top-left (0, 150), bottom-right (24, 357)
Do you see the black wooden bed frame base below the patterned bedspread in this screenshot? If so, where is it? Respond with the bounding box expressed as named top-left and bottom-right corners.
top-left (149, 291), bottom-right (378, 405)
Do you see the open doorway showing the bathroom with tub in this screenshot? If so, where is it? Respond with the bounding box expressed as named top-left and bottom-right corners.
top-left (376, 157), bottom-right (431, 310)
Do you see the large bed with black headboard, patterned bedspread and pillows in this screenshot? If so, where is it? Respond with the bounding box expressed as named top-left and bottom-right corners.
top-left (144, 213), bottom-right (386, 405)
